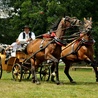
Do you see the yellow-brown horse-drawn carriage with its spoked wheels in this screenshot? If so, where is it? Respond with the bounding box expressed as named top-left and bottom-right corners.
top-left (0, 51), bottom-right (51, 82)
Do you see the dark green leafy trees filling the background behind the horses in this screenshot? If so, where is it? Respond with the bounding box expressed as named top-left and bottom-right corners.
top-left (0, 0), bottom-right (98, 54)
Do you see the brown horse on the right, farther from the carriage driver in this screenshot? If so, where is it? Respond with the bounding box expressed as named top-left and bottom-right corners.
top-left (61, 18), bottom-right (98, 83)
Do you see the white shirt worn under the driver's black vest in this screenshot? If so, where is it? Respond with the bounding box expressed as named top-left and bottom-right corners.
top-left (18, 31), bottom-right (35, 42)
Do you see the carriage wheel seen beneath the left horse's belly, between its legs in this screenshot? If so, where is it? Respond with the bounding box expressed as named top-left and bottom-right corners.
top-left (40, 66), bottom-right (50, 81)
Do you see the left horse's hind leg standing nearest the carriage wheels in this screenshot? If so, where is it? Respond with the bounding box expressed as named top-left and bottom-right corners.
top-left (31, 59), bottom-right (40, 84)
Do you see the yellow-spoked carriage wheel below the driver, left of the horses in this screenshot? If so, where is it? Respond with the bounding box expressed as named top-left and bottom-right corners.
top-left (12, 63), bottom-right (22, 82)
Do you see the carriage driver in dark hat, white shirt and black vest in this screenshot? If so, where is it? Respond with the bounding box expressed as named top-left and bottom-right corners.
top-left (5, 25), bottom-right (35, 58)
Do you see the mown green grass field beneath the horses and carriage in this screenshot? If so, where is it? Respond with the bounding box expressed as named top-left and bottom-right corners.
top-left (0, 69), bottom-right (98, 98)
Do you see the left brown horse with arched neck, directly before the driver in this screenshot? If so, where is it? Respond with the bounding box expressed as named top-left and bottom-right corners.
top-left (27, 16), bottom-right (80, 84)
